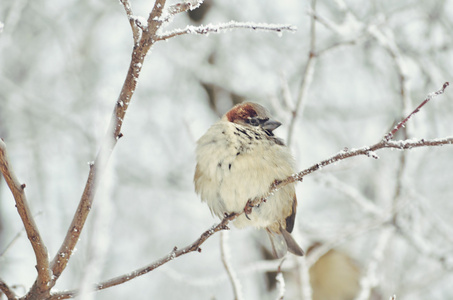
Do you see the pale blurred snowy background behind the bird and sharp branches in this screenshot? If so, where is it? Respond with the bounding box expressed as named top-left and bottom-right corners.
top-left (0, 0), bottom-right (453, 300)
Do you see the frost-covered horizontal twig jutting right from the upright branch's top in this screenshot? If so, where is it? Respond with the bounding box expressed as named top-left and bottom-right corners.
top-left (157, 21), bottom-right (296, 40)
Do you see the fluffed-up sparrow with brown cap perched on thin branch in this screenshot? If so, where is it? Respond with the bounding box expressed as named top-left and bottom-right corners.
top-left (194, 102), bottom-right (304, 258)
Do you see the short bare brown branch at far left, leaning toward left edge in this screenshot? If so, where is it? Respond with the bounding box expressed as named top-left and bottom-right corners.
top-left (0, 139), bottom-right (51, 294)
